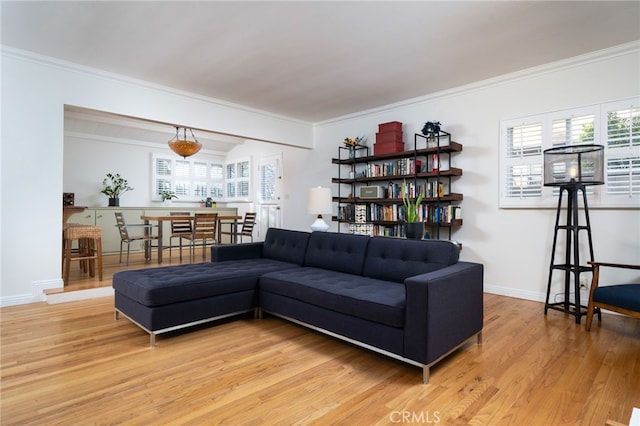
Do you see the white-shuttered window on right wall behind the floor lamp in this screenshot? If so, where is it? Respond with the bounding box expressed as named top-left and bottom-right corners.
top-left (500, 100), bottom-right (640, 208)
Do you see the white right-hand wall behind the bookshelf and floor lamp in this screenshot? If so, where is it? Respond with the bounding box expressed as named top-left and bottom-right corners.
top-left (314, 44), bottom-right (640, 300)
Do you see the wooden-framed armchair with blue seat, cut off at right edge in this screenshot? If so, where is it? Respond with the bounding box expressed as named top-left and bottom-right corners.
top-left (585, 262), bottom-right (640, 331)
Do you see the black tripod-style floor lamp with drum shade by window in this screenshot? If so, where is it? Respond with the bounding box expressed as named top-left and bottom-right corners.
top-left (544, 145), bottom-right (604, 324)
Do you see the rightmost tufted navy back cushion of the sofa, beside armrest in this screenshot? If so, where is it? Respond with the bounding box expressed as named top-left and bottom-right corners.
top-left (363, 237), bottom-right (460, 283)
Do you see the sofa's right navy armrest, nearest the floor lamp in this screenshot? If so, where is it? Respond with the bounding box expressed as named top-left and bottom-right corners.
top-left (404, 262), bottom-right (484, 364)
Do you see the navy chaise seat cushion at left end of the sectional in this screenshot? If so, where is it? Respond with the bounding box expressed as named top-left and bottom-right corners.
top-left (113, 258), bottom-right (298, 306)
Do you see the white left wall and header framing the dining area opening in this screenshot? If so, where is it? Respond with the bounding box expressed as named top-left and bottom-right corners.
top-left (0, 48), bottom-right (313, 305)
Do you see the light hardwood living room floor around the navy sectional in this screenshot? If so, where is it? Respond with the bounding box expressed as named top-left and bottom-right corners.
top-left (0, 262), bottom-right (640, 426)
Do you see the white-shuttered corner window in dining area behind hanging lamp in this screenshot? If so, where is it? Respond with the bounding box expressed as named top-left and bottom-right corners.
top-left (151, 155), bottom-right (251, 202)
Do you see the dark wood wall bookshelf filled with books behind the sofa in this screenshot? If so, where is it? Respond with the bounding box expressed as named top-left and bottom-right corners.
top-left (331, 131), bottom-right (463, 239)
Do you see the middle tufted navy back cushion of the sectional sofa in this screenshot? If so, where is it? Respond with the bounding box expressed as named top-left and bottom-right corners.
top-left (304, 232), bottom-right (370, 274)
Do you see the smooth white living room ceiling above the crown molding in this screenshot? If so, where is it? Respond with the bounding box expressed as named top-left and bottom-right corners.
top-left (0, 1), bottom-right (640, 149)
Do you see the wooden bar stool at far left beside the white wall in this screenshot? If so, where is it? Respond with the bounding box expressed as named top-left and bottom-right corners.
top-left (62, 224), bottom-right (102, 285)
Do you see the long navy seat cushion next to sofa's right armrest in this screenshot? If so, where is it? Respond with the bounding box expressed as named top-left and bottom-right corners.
top-left (260, 267), bottom-right (405, 327)
